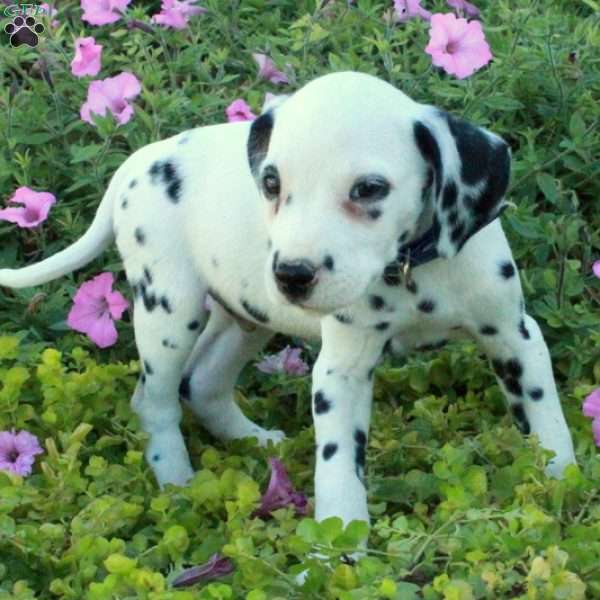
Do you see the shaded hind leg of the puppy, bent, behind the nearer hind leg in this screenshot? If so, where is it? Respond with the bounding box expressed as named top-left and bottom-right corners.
top-left (180, 302), bottom-right (285, 445)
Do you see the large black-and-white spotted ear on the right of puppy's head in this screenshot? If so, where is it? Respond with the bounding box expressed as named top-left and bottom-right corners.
top-left (413, 107), bottom-right (510, 258)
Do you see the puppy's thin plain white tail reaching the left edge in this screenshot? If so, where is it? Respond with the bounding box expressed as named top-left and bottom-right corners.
top-left (0, 177), bottom-right (116, 288)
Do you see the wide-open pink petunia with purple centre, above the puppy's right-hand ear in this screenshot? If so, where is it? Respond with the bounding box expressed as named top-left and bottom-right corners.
top-left (425, 13), bottom-right (492, 79)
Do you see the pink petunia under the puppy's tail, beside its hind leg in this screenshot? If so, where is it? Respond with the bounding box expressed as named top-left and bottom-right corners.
top-left (67, 273), bottom-right (129, 348)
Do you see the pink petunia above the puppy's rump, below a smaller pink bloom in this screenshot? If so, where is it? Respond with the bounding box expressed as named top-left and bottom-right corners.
top-left (80, 72), bottom-right (142, 125)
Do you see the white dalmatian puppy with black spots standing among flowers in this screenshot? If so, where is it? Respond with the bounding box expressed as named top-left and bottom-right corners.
top-left (0, 72), bottom-right (575, 523)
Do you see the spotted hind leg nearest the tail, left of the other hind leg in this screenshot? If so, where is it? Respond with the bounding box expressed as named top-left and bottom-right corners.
top-left (128, 263), bottom-right (206, 486)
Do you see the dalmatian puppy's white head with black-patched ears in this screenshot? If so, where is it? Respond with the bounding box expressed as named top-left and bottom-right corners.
top-left (248, 72), bottom-right (510, 314)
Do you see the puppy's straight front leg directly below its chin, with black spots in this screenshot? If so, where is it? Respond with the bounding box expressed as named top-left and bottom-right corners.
top-left (312, 317), bottom-right (385, 525)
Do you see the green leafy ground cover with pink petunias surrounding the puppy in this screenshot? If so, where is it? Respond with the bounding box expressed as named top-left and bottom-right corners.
top-left (0, 0), bottom-right (600, 600)
